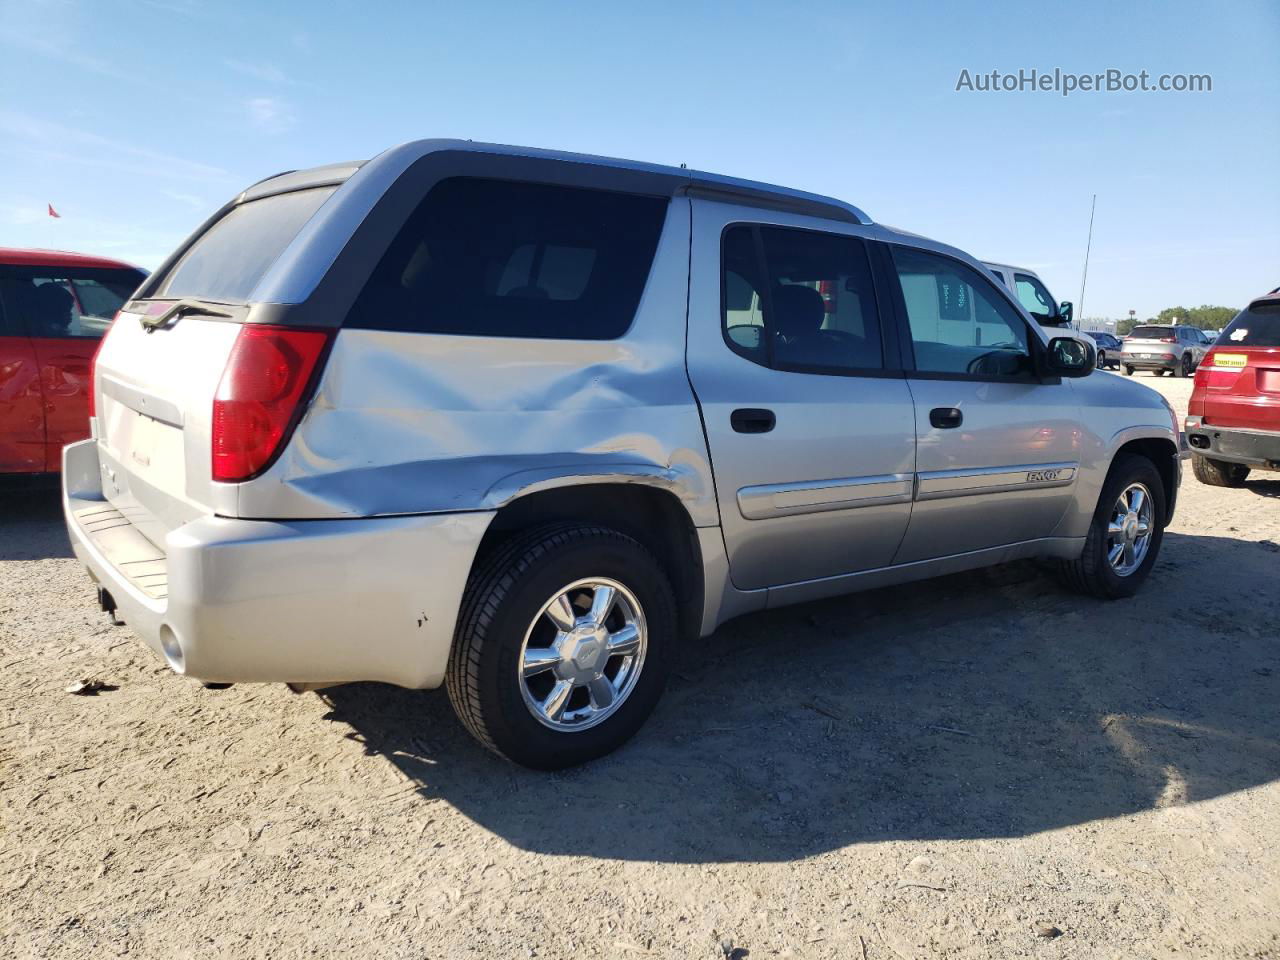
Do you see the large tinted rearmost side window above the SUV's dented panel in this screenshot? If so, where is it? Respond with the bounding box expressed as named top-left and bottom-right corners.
top-left (347, 178), bottom-right (667, 340)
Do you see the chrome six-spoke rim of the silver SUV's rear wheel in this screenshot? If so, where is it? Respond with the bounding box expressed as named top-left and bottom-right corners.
top-left (518, 577), bottom-right (649, 732)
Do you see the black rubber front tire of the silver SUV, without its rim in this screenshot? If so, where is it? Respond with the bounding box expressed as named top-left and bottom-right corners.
top-left (1060, 453), bottom-right (1165, 600)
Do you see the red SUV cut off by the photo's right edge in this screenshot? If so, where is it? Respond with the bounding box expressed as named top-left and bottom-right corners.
top-left (1187, 288), bottom-right (1280, 486)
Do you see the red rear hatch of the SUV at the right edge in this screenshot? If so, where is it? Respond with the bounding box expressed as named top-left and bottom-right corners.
top-left (1188, 300), bottom-right (1280, 433)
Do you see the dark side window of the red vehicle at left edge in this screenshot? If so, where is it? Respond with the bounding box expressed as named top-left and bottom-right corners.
top-left (0, 268), bottom-right (146, 339)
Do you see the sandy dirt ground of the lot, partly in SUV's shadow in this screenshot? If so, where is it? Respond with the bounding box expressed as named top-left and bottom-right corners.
top-left (0, 376), bottom-right (1280, 960)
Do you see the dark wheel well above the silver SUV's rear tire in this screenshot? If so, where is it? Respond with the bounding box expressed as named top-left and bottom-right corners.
top-left (472, 484), bottom-right (704, 647)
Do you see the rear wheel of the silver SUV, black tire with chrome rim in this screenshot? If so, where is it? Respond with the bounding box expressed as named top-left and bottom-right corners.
top-left (445, 524), bottom-right (677, 771)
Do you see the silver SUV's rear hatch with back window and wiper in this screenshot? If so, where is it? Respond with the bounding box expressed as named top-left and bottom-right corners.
top-left (93, 186), bottom-right (335, 544)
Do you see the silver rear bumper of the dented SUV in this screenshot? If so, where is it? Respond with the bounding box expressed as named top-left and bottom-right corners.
top-left (63, 440), bottom-right (493, 687)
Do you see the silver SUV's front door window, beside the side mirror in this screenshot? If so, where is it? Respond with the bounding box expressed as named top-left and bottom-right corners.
top-left (892, 246), bottom-right (1034, 379)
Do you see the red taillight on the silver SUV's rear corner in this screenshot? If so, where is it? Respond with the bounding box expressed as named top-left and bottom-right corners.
top-left (212, 324), bottom-right (330, 484)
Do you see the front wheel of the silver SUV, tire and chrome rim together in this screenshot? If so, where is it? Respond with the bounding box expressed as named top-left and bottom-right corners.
top-left (1062, 453), bottom-right (1165, 600)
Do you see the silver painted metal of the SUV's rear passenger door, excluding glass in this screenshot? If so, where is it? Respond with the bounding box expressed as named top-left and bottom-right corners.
top-left (689, 200), bottom-right (915, 590)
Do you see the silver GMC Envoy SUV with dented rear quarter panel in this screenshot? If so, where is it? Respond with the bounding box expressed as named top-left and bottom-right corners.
top-left (63, 141), bottom-right (1181, 768)
